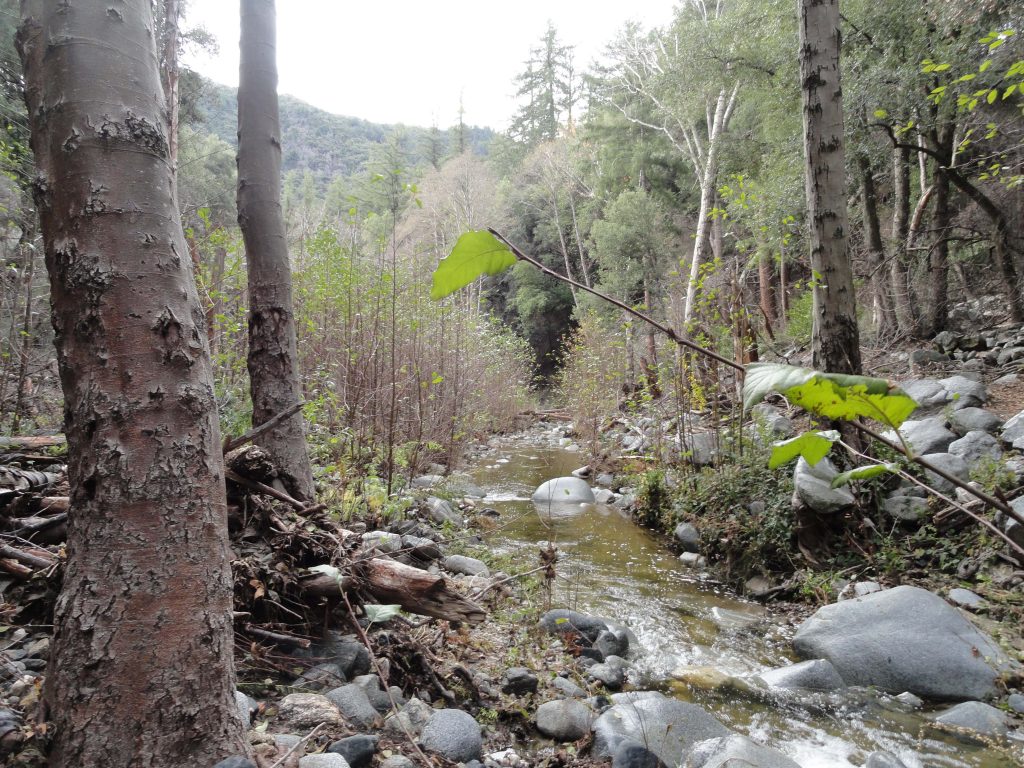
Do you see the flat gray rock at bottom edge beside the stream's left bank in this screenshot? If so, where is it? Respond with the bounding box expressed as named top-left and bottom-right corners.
top-left (593, 692), bottom-right (729, 765)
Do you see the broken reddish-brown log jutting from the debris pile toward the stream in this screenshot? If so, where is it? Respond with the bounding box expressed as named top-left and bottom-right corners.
top-left (302, 557), bottom-right (487, 624)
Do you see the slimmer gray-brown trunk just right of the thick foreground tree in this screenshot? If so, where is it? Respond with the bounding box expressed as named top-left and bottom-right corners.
top-left (238, 0), bottom-right (313, 501)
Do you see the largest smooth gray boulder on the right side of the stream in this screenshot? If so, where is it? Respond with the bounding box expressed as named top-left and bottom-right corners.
top-left (793, 586), bottom-right (1011, 700)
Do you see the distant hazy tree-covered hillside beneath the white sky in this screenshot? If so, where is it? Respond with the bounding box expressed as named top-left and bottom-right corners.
top-left (194, 78), bottom-right (495, 184)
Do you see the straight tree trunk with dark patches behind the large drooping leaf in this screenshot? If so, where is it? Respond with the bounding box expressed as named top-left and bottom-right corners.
top-left (799, 0), bottom-right (860, 373)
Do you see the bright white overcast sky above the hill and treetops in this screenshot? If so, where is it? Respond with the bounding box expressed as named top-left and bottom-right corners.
top-left (185, 0), bottom-right (675, 129)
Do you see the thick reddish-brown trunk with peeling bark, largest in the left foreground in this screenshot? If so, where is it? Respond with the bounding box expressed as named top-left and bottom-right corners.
top-left (18, 0), bottom-right (248, 768)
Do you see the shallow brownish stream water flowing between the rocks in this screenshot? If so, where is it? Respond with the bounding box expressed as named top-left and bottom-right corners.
top-left (471, 433), bottom-right (1024, 768)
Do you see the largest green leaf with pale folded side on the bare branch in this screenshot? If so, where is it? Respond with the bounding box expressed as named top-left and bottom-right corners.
top-left (743, 362), bottom-right (918, 429)
